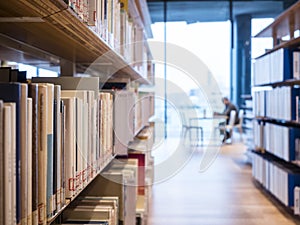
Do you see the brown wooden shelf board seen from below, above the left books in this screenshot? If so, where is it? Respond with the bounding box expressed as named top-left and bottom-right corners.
top-left (0, 0), bottom-right (150, 84)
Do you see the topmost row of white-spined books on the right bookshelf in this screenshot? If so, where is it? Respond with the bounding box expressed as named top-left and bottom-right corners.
top-left (253, 48), bottom-right (299, 85)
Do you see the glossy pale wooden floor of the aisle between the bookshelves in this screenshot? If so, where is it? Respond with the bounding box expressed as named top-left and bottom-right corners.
top-left (148, 137), bottom-right (300, 225)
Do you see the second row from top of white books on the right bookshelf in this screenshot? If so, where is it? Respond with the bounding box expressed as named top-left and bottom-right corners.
top-left (253, 86), bottom-right (300, 121)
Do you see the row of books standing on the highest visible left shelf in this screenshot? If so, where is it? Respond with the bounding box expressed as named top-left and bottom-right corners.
top-left (67, 0), bottom-right (148, 77)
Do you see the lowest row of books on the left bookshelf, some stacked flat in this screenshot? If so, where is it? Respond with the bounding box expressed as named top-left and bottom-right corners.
top-left (53, 123), bottom-right (154, 225)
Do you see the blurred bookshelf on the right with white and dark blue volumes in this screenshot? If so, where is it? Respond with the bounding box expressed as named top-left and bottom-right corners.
top-left (252, 2), bottom-right (300, 215)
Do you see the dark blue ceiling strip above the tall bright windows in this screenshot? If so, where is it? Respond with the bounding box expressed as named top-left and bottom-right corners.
top-left (147, 0), bottom-right (296, 23)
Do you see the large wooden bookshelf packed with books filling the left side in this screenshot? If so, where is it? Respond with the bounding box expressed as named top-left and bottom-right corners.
top-left (0, 0), bottom-right (154, 225)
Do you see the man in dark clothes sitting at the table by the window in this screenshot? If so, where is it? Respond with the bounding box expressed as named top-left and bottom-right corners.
top-left (214, 97), bottom-right (239, 143)
